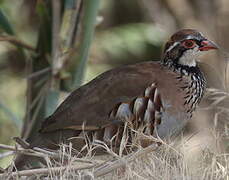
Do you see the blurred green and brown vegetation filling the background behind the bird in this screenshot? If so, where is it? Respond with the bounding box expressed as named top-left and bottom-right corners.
top-left (0, 0), bottom-right (229, 179)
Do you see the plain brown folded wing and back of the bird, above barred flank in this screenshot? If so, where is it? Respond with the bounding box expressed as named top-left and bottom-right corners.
top-left (41, 62), bottom-right (174, 132)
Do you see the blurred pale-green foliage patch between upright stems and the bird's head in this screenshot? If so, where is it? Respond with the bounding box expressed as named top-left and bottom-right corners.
top-left (93, 23), bottom-right (166, 65)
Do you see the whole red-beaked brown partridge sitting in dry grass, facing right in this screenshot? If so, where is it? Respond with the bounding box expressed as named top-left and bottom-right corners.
top-left (15, 29), bottom-right (218, 168)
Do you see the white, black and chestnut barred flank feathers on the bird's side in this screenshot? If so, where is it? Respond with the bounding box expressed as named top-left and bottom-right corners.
top-left (103, 83), bottom-right (164, 141)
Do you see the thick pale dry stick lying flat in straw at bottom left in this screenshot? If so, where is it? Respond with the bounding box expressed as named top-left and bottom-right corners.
top-left (0, 163), bottom-right (95, 179)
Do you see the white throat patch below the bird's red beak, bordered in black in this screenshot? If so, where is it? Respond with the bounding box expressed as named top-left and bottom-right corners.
top-left (178, 47), bottom-right (201, 67)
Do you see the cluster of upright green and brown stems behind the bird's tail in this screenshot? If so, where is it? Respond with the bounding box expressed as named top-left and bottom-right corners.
top-left (22, 0), bottom-right (99, 141)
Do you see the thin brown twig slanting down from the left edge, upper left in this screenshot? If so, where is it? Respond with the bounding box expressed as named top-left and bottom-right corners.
top-left (0, 35), bottom-right (36, 51)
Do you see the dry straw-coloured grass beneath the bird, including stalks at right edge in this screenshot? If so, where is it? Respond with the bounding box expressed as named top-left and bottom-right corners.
top-left (0, 89), bottom-right (229, 180)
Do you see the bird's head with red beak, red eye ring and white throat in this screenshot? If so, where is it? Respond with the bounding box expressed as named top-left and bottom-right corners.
top-left (163, 29), bottom-right (218, 67)
